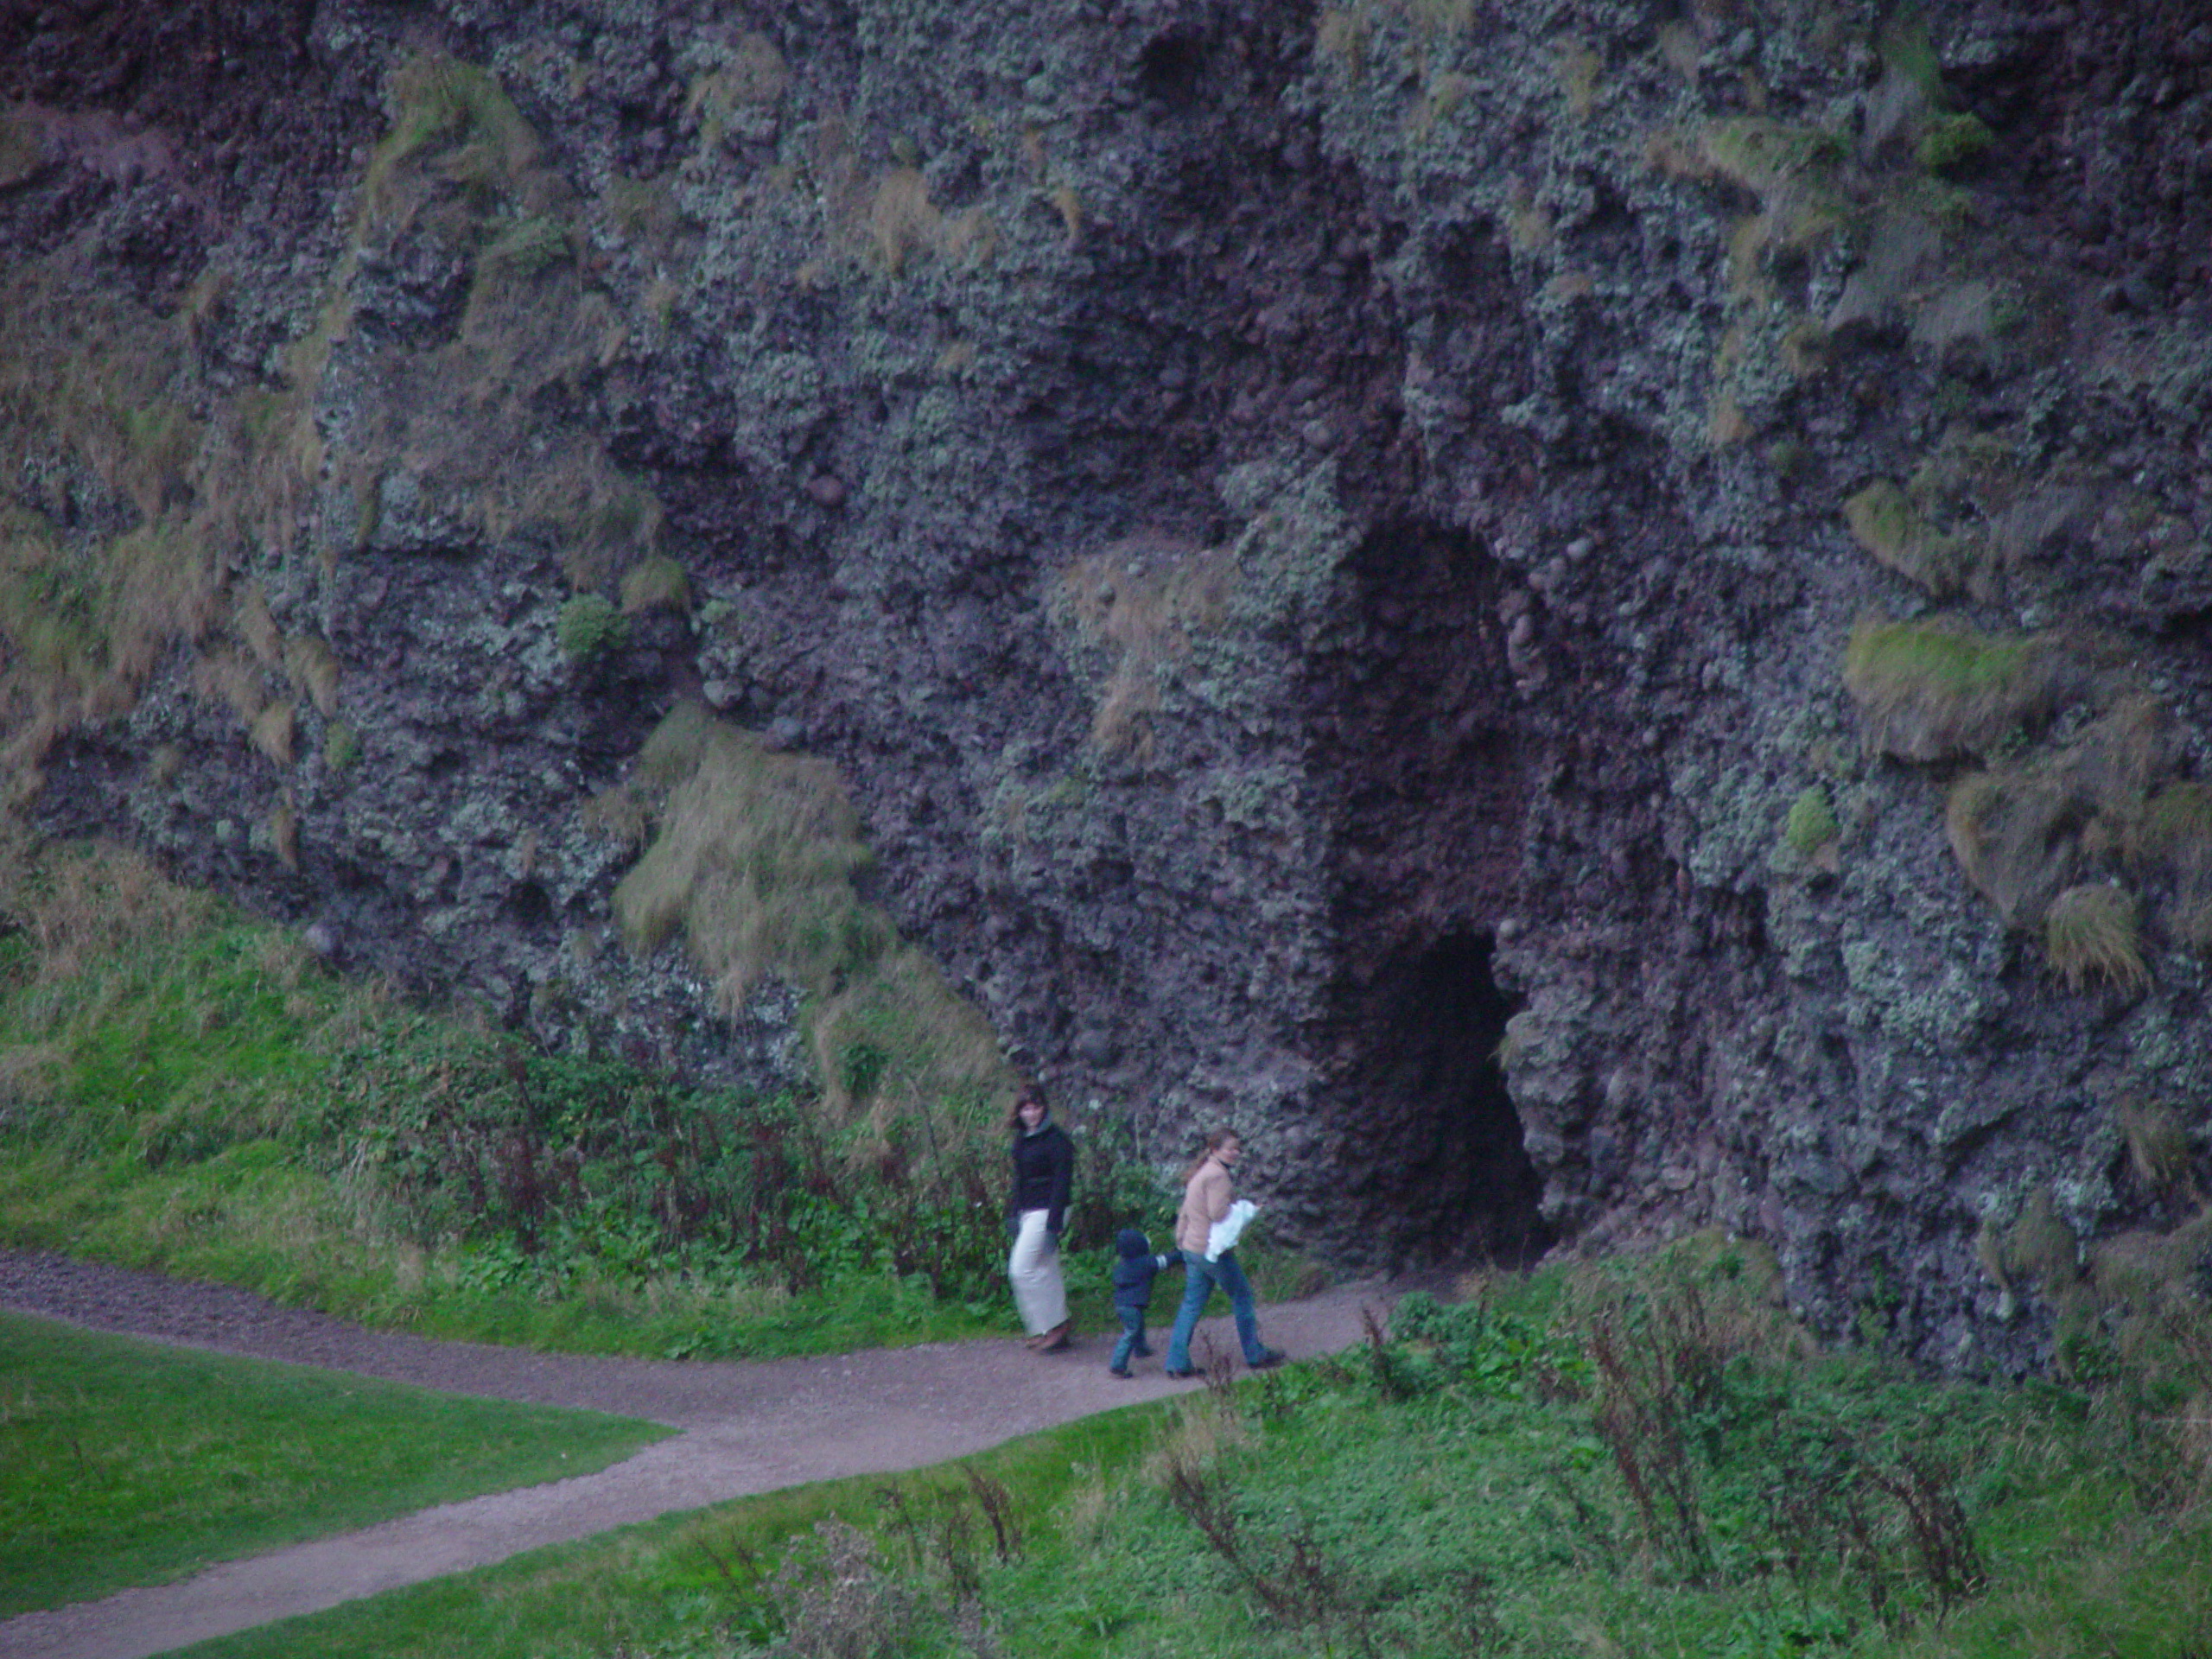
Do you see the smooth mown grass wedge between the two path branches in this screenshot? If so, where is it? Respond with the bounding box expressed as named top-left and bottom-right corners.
top-left (0, 1314), bottom-right (672, 1617)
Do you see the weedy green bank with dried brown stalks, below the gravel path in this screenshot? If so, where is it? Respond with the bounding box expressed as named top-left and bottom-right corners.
top-left (163, 1241), bottom-right (2212, 1659)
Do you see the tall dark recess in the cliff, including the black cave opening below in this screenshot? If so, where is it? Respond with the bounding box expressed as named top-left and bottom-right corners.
top-left (1312, 518), bottom-right (1553, 1268)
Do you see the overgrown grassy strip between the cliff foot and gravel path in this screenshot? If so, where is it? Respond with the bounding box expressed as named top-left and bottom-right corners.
top-left (0, 847), bottom-right (1303, 1358)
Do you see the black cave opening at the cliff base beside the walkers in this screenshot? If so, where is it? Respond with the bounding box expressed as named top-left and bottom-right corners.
top-left (1371, 929), bottom-right (1553, 1268)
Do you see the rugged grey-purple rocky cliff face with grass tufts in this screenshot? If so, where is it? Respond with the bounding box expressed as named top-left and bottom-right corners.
top-left (0, 0), bottom-right (2212, 1367)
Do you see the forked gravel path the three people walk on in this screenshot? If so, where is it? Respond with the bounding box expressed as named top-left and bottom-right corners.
top-left (0, 1249), bottom-right (1391, 1659)
